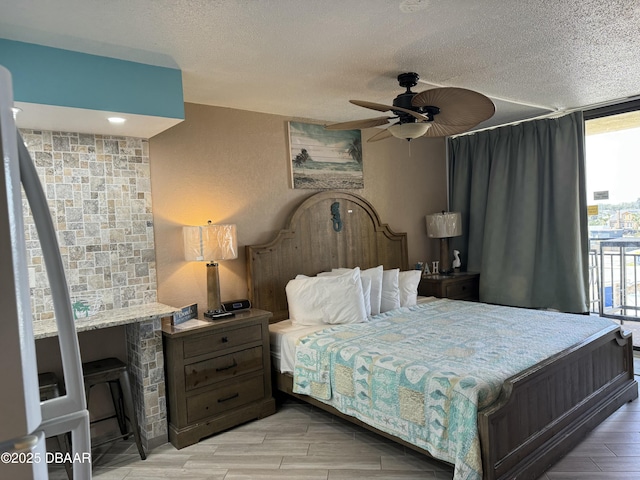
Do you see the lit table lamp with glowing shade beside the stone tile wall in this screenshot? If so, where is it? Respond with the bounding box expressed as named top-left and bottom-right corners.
top-left (182, 220), bottom-right (238, 318)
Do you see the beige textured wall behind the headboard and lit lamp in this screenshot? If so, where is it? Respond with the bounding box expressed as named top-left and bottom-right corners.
top-left (149, 104), bottom-right (446, 310)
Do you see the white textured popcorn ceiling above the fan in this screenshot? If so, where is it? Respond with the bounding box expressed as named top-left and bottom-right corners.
top-left (0, 0), bottom-right (640, 135)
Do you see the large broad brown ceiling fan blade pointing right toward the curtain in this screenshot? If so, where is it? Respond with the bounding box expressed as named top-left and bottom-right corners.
top-left (411, 87), bottom-right (496, 128)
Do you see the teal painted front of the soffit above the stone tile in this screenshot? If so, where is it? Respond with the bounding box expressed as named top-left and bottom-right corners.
top-left (0, 38), bottom-right (184, 119)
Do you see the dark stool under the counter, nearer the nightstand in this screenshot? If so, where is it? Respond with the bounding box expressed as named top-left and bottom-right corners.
top-left (82, 358), bottom-right (147, 460)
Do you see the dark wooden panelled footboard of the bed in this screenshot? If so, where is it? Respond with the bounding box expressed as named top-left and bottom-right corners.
top-left (478, 327), bottom-right (638, 480)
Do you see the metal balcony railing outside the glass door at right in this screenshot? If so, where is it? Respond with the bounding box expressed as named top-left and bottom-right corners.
top-left (589, 237), bottom-right (640, 322)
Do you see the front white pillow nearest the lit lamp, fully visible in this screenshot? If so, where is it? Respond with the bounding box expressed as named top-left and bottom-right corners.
top-left (286, 269), bottom-right (367, 325)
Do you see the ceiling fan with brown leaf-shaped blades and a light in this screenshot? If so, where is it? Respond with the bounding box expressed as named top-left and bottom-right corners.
top-left (325, 72), bottom-right (496, 142)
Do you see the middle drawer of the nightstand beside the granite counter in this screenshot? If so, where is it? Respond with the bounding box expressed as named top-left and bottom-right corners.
top-left (184, 347), bottom-right (262, 391)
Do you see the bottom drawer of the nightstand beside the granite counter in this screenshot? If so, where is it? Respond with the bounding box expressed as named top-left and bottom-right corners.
top-left (187, 372), bottom-right (264, 422)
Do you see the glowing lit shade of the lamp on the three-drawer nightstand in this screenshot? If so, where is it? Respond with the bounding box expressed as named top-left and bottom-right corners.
top-left (182, 224), bottom-right (238, 261)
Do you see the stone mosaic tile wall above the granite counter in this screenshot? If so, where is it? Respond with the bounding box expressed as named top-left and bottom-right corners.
top-left (21, 130), bottom-right (157, 321)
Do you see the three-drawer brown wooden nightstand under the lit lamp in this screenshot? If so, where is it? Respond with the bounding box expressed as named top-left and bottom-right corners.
top-left (162, 309), bottom-right (276, 449)
